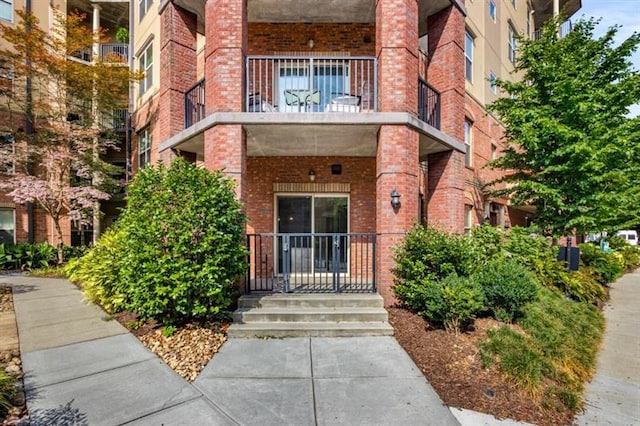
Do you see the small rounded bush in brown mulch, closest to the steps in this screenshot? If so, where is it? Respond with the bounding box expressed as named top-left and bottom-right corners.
top-left (418, 274), bottom-right (484, 332)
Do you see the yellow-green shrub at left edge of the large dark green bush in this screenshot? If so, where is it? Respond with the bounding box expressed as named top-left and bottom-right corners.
top-left (64, 224), bottom-right (127, 313)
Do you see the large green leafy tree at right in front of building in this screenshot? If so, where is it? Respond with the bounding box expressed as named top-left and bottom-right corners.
top-left (489, 17), bottom-right (640, 236)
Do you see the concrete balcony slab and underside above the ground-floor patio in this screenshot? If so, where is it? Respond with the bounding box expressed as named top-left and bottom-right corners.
top-left (159, 113), bottom-right (466, 160)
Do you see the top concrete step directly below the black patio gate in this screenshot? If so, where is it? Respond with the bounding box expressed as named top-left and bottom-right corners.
top-left (238, 293), bottom-right (384, 308)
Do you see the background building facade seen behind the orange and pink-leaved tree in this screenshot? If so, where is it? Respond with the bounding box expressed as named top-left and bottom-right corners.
top-left (0, 0), bottom-right (131, 245)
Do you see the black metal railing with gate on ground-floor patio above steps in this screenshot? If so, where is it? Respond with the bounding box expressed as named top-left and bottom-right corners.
top-left (246, 233), bottom-right (376, 293)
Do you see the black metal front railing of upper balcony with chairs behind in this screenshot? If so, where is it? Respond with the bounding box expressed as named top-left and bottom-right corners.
top-left (245, 56), bottom-right (378, 112)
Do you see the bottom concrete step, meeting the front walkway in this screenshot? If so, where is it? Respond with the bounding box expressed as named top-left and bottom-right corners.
top-left (227, 322), bottom-right (393, 338)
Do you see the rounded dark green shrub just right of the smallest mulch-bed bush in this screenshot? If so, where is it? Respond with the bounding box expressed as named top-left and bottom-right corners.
top-left (475, 259), bottom-right (538, 322)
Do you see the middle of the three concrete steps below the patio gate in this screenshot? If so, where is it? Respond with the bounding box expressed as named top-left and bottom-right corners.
top-left (233, 306), bottom-right (388, 323)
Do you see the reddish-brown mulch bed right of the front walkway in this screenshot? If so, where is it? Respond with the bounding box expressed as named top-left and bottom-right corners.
top-left (388, 307), bottom-right (574, 426)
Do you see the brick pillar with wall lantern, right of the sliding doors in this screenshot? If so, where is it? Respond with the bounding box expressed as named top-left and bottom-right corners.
top-left (376, 0), bottom-right (419, 306)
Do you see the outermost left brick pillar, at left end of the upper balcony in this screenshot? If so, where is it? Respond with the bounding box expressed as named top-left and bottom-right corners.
top-left (157, 2), bottom-right (197, 164)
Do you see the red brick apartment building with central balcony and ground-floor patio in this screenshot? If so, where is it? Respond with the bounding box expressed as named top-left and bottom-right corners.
top-left (132, 0), bottom-right (580, 303)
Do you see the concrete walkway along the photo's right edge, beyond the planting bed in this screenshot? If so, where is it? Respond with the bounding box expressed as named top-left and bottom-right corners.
top-left (576, 272), bottom-right (640, 426)
